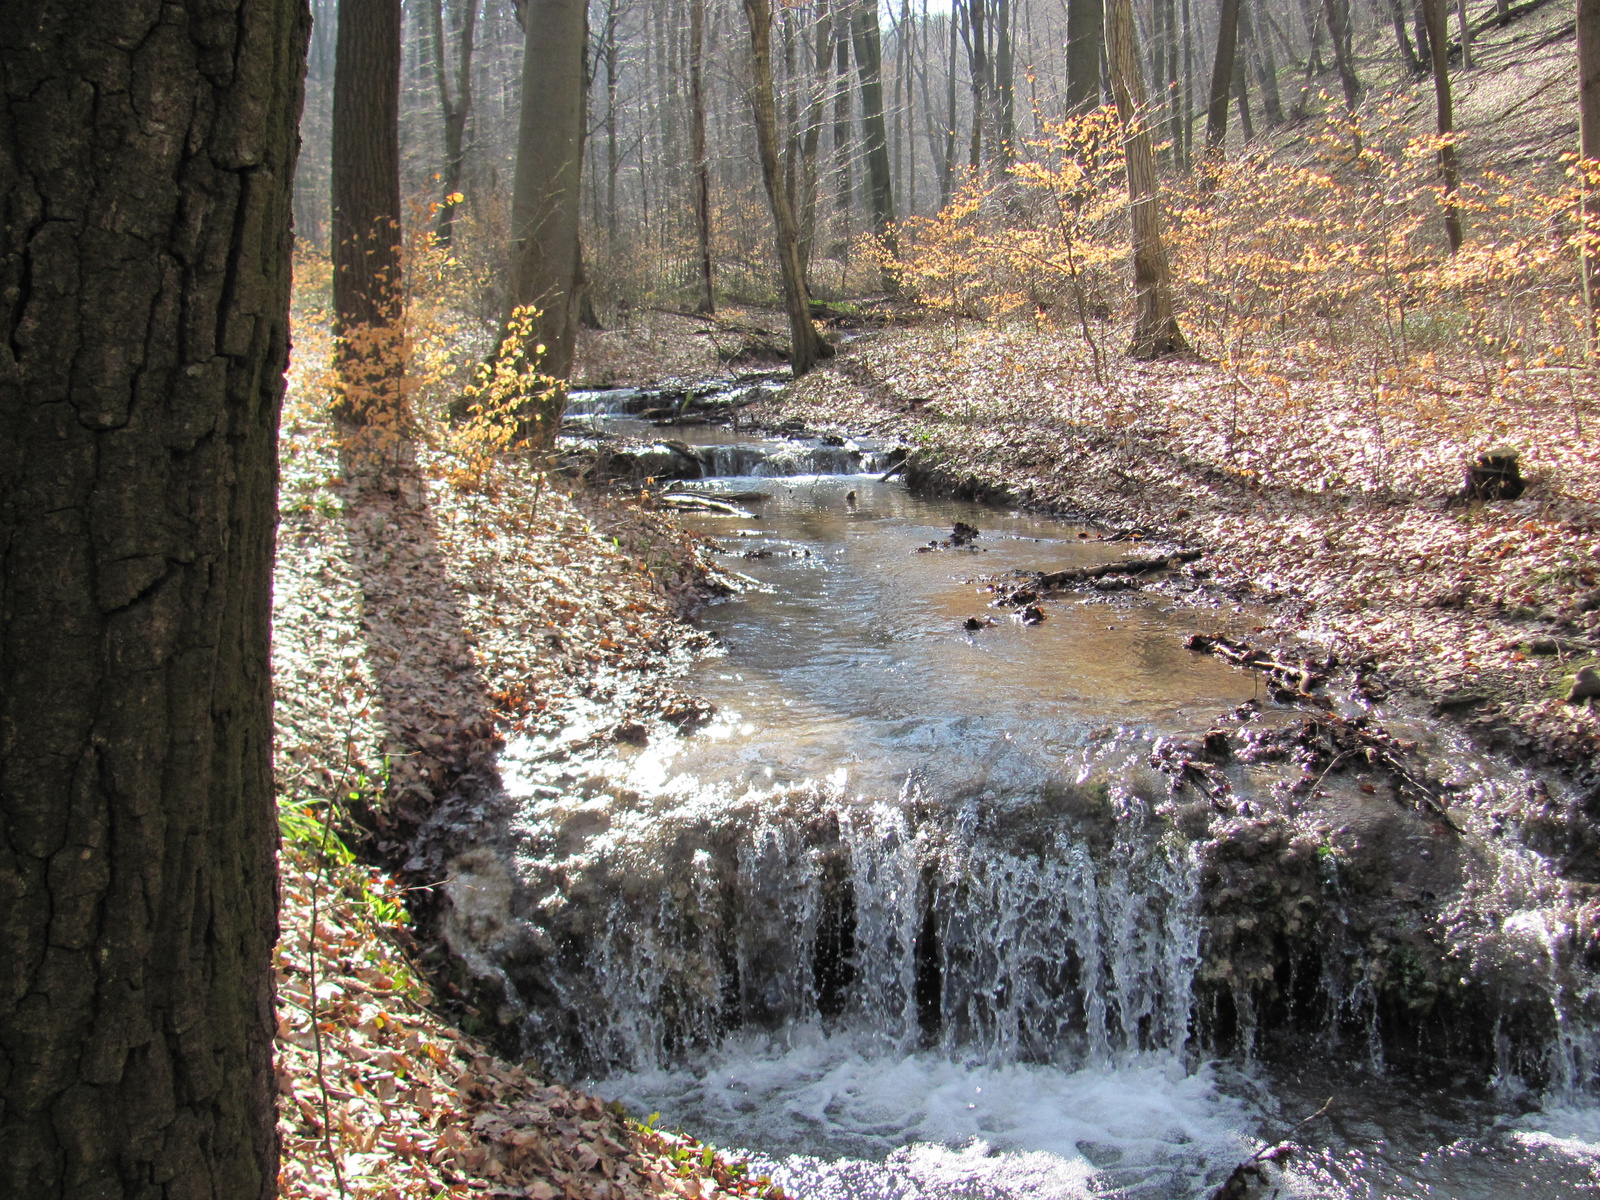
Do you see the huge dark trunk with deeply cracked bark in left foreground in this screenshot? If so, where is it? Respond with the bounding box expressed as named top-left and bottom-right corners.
top-left (0, 0), bottom-right (309, 1200)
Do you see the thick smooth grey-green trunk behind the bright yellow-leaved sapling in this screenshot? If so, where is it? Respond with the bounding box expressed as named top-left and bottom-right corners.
top-left (510, 0), bottom-right (587, 401)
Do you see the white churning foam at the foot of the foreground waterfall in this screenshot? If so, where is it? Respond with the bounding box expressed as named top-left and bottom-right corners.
top-left (594, 1029), bottom-right (1261, 1200)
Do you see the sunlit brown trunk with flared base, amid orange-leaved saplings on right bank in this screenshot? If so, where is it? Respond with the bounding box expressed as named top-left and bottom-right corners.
top-left (1106, 0), bottom-right (1196, 358)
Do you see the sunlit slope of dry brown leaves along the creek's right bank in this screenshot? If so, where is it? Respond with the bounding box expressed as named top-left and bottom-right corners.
top-left (752, 322), bottom-right (1600, 763)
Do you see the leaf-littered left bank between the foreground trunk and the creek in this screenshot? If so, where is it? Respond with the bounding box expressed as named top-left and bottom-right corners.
top-left (274, 396), bottom-right (781, 1200)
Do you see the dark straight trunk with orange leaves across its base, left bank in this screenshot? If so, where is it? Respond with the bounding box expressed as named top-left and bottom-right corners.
top-left (333, 0), bottom-right (405, 434)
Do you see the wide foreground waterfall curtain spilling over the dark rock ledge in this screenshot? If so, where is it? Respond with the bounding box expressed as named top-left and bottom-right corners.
top-left (509, 780), bottom-right (1200, 1074)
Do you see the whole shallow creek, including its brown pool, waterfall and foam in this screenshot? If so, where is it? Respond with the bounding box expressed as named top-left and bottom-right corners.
top-left (486, 397), bottom-right (1600, 1200)
